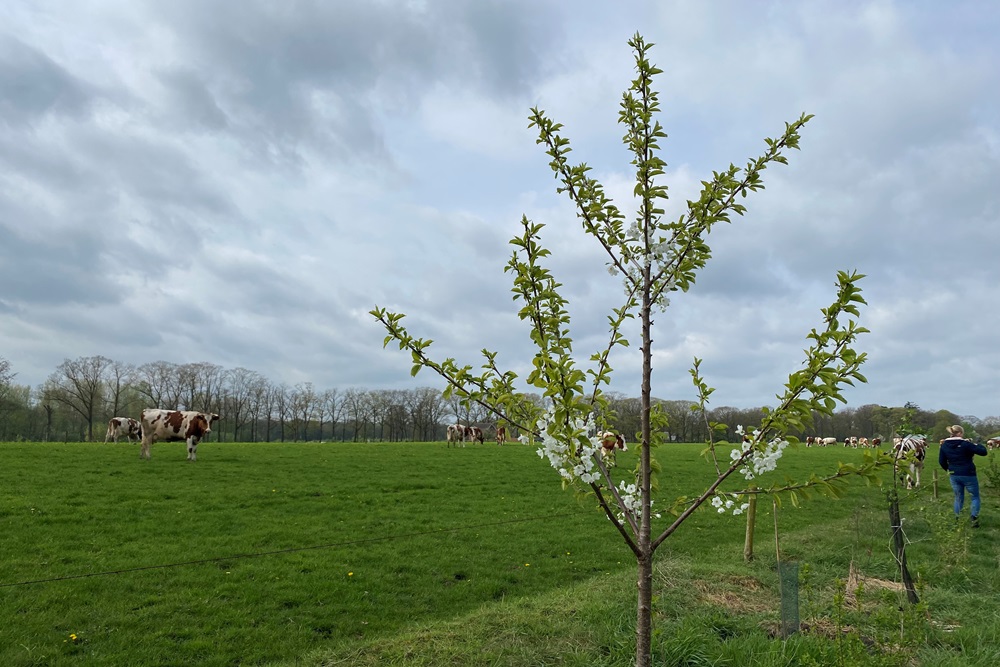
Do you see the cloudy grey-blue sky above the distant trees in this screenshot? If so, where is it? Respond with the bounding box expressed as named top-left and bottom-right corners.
top-left (0, 0), bottom-right (1000, 418)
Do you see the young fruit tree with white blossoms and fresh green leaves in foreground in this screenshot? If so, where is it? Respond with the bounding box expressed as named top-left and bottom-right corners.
top-left (371, 35), bottom-right (879, 667)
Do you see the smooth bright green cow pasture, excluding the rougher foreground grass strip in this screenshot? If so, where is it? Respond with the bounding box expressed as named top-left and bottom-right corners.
top-left (0, 442), bottom-right (1000, 666)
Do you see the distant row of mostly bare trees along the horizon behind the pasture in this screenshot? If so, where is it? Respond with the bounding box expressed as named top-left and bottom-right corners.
top-left (0, 356), bottom-right (1000, 442)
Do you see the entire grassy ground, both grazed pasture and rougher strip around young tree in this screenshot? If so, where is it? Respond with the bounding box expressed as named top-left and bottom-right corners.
top-left (0, 442), bottom-right (1000, 667)
